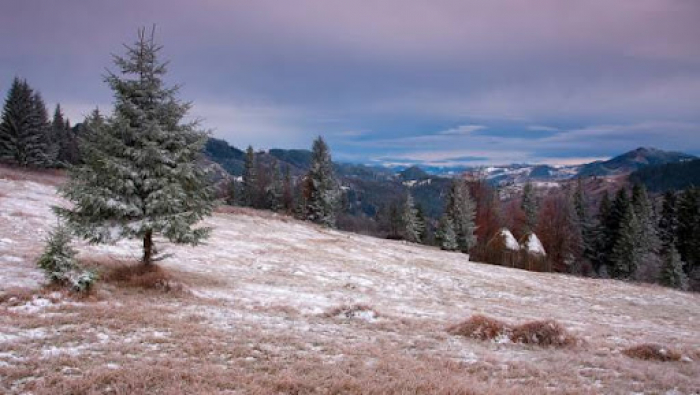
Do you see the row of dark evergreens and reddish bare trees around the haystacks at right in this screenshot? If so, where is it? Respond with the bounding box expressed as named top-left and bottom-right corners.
top-left (474, 180), bottom-right (700, 290)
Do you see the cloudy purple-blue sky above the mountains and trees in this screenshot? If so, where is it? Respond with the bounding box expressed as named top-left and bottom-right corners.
top-left (0, 0), bottom-right (700, 165)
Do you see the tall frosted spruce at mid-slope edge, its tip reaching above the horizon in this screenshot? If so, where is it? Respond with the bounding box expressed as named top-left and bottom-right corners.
top-left (306, 136), bottom-right (339, 227)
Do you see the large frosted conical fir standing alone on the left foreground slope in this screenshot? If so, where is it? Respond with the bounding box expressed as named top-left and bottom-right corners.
top-left (56, 29), bottom-right (214, 265)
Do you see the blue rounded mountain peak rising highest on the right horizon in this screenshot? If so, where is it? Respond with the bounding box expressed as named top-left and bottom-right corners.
top-left (578, 147), bottom-right (697, 177)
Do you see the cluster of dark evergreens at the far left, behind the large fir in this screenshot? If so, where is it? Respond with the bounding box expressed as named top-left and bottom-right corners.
top-left (0, 78), bottom-right (81, 168)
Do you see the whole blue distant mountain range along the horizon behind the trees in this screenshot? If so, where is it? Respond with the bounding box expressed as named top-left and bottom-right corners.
top-left (205, 139), bottom-right (700, 223)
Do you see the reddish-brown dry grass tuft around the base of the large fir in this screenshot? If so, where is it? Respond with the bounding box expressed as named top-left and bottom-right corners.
top-left (100, 264), bottom-right (185, 293)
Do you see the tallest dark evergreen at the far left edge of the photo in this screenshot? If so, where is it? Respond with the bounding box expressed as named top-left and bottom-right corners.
top-left (0, 78), bottom-right (54, 167)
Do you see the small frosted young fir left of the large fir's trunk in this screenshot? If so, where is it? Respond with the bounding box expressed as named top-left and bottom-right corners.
top-left (37, 225), bottom-right (97, 293)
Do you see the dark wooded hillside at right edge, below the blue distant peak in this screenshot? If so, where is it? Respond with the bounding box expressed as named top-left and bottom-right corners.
top-left (630, 159), bottom-right (700, 192)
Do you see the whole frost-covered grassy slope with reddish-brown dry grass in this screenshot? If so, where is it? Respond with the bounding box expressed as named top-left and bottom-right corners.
top-left (0, 168), bottom-right (700, 394)
